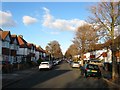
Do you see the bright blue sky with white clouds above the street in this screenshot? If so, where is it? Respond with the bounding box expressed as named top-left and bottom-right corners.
top-left (0, 2), bottom-right (96, 53)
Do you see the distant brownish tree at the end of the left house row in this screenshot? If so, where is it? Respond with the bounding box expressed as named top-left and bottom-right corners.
top-left (46, 41), bottom-right (63, 58)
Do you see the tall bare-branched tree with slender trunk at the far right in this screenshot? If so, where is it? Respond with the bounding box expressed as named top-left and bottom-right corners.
top-left (89, 0), bottom-right (120, 81)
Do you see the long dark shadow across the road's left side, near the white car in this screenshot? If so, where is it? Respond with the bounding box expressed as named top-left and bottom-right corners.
top-left (4, 69), bottom-right (71, 88)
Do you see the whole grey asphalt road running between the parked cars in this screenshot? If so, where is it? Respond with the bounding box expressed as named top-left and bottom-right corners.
top-left (5, 61), bottom-right (112, 90)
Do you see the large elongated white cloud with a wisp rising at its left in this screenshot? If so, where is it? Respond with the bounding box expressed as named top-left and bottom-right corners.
top-left (42, 7), bottom-right (87, 31)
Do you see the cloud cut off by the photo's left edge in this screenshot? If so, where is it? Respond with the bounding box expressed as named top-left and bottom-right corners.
top-left (0, 11), bottom-right (16, 27)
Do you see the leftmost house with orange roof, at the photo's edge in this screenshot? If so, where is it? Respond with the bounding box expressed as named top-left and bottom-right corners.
top-left (0, 30), bottom-right (13, 73)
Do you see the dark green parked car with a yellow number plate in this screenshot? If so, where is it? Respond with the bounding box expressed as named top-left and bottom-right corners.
top-left (81, 64), bottom-right (101, 78)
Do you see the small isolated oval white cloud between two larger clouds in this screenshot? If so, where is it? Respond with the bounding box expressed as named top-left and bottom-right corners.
top-left (23, 16), bottom-right (38, 25)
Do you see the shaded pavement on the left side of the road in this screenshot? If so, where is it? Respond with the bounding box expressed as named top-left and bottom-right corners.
top-left (2, 66), bottom-right (38, 88)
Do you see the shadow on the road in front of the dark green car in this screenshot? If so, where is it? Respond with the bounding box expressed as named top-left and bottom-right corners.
top-left (66, 76), bottom-right (109, 90)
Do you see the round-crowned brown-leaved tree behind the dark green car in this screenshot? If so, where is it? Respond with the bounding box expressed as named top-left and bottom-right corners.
top-left (73, 24), bottom-right (98, 66)
